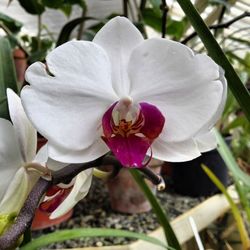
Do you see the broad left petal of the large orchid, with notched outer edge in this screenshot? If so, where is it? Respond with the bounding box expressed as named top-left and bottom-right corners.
top-left (21, 41), bottom-right (117, 154)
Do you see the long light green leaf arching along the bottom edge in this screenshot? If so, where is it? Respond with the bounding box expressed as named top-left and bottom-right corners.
top-left (20, 228), bottom-right (171, 250)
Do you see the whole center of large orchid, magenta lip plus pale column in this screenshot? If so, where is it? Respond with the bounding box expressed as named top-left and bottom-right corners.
top-left (102, 97), bottom-right (165, 167)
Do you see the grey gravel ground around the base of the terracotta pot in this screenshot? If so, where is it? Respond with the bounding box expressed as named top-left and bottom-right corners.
top-left (32, 179), bottom-right (204, 249)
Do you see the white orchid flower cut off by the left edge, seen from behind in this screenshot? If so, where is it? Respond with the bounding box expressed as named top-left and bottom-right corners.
top-left (0, 89), bottom-right (44, 215)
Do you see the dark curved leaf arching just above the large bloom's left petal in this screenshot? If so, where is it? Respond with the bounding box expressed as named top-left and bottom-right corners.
top-left (56, 17), bottom-right (96, 47)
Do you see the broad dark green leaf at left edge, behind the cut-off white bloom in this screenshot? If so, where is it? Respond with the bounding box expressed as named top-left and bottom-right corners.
top-left (0, 38), bottom-right (18, 120)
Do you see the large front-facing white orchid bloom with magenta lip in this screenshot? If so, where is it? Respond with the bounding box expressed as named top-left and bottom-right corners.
top-left (21, 17), bottom-right (226, 168)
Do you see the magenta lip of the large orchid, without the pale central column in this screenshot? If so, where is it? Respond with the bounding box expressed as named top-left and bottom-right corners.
top-left (102, 102), bottom-right (165, 168)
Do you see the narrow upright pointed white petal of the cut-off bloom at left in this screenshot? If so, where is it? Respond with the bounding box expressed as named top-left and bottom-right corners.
top-left (7, 89), bottom-right (37, 162)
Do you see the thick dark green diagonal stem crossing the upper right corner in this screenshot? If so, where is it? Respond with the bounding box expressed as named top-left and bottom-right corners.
top-left (177, 0), bottom-right (250, 121)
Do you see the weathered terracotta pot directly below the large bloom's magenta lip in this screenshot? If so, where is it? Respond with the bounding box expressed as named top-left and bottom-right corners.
top-left (107, 160), bottom-right (162, 214)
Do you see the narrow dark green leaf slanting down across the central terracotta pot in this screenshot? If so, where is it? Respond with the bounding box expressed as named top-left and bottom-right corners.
top-left (130, 169), bottom-right (181, 250)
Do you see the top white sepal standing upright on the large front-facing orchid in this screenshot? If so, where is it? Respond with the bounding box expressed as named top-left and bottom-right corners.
top-left (93, 17), bottom-right (143, 97)
